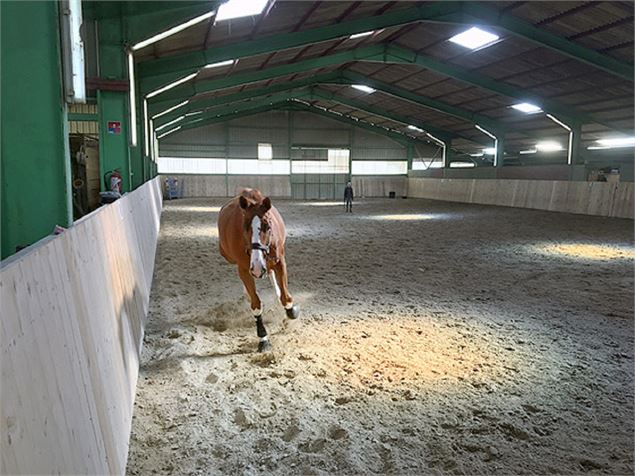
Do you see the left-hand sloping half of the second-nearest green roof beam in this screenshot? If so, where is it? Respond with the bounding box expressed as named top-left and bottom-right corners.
top-left (141, 45), bottom-right (386, 103)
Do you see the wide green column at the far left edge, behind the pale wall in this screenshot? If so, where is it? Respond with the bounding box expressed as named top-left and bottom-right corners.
top-left (0, 1), bottom-right (72, 258)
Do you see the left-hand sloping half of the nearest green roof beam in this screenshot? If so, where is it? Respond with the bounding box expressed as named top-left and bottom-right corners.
top-left (138, 2), bottom-right (459, 82)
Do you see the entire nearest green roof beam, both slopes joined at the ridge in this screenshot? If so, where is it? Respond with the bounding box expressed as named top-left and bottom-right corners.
top-left (139, 2), bottom-right (633, 83)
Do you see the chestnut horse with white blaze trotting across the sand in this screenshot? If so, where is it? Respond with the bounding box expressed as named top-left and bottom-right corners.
top-left (218, 188), bottom-right (300, 352)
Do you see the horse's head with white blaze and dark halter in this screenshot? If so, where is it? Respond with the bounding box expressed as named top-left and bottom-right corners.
top-left (239, 196), bottom-right (271, 278)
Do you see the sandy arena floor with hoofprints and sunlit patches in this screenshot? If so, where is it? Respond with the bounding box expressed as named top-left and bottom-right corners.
top-left (128, 195), bottom-right (635, 475)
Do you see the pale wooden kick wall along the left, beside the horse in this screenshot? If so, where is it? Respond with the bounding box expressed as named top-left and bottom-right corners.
top-left (0, 178), bottom-right (162, 474)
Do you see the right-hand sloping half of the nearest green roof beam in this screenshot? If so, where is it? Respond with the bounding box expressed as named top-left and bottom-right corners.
top-left (450, 2), bottom-right (634, 81)
